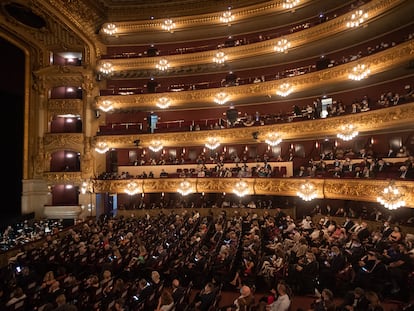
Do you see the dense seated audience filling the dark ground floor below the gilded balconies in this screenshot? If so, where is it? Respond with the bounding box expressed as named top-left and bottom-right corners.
top-left (0, 208), bottom-right (414, 311)
